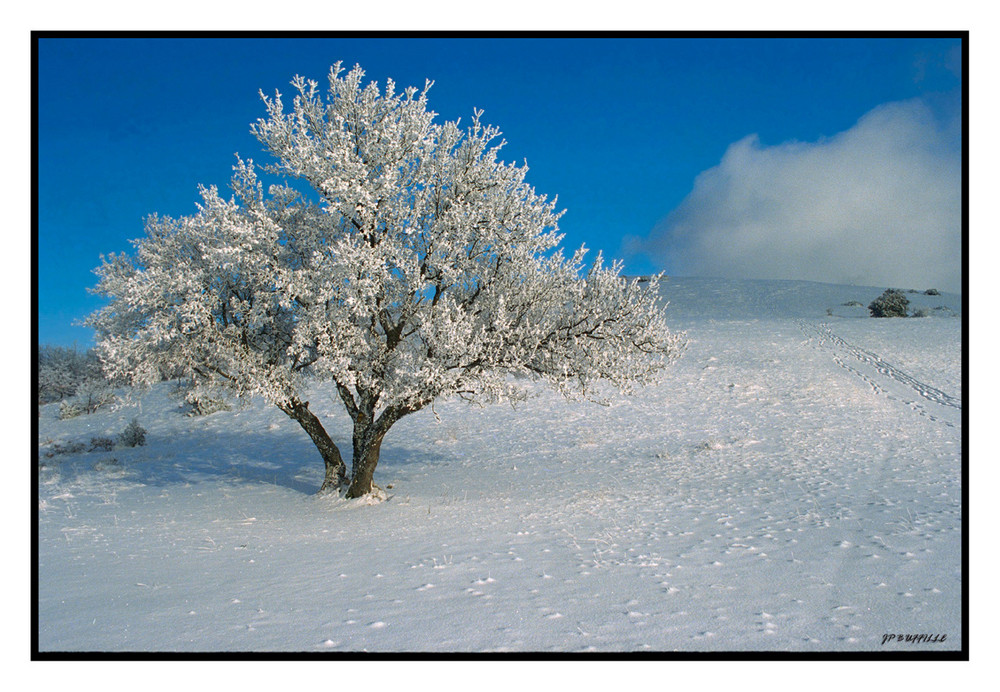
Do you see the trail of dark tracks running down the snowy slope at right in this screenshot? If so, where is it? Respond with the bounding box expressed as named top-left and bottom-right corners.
top-left (796, 320), bottom-right (962, 427)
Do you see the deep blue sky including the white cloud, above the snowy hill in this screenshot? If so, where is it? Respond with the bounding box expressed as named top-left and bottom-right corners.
top-left (37, 37), bottom-right (962, 347)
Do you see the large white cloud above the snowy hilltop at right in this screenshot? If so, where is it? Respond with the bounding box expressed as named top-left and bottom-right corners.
top-left (645, 100), bottom-right (962, 292)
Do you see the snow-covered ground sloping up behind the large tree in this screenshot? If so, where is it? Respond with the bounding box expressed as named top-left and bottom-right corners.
top-left (38, 279), bottom-right (964, 652)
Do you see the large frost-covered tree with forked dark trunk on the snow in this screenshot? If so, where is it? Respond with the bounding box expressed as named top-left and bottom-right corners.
top-left (88, 63), bottom-right (683, 497)
